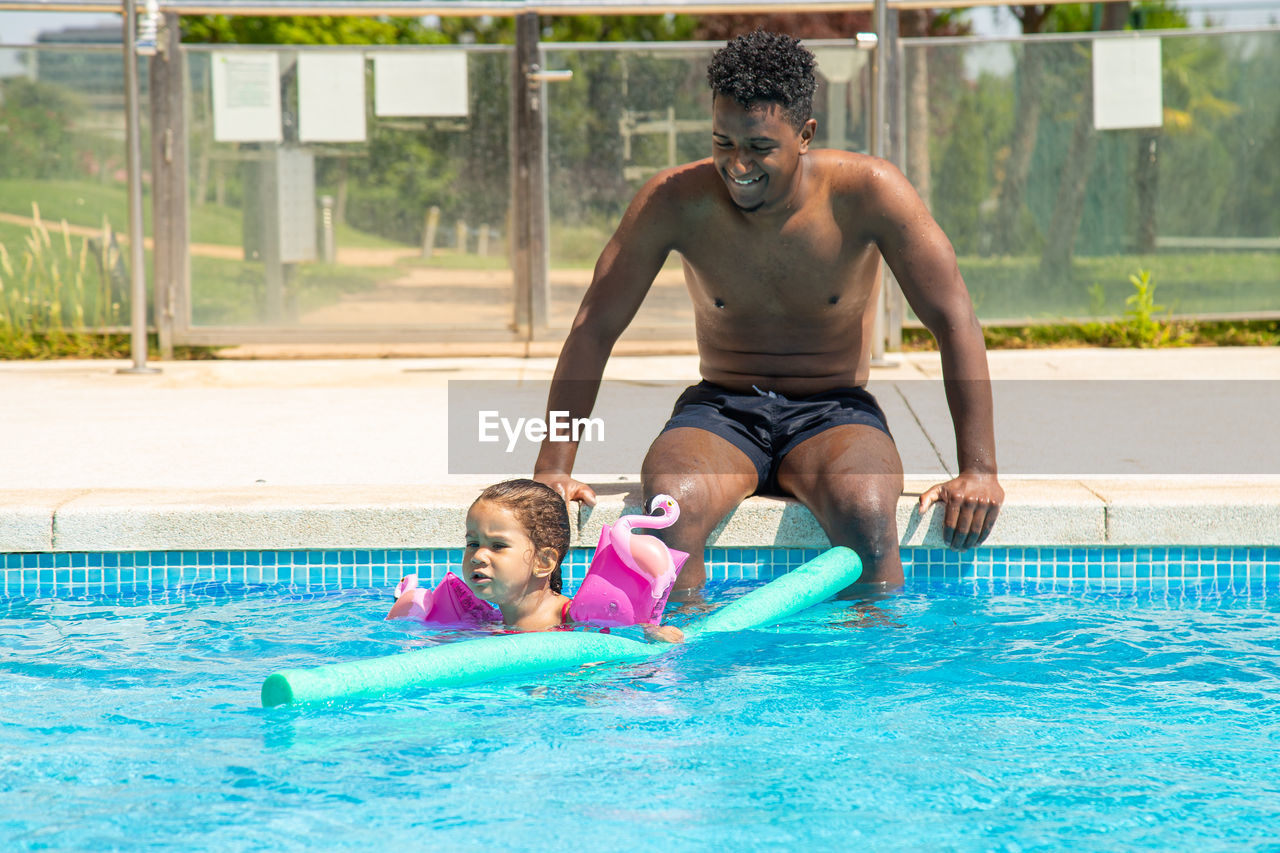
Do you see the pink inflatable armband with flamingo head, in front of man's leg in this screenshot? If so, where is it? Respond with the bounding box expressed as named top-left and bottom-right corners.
top-left (568, 494), bottom-right (689, 626)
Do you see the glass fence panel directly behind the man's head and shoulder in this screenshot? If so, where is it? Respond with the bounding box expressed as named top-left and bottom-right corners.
top-left (543, 41), bottom-right (870, 338)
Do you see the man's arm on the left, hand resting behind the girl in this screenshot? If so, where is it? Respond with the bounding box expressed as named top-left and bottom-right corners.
top-left (534, 173), bottom-right (678, 506)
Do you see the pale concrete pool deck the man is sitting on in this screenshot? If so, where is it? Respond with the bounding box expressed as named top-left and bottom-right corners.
top-left (0, 348), bottom-right (1280, 552)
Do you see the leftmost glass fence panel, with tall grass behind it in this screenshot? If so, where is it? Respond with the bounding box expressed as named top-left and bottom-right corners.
top-left (0, 44), bottom-right (150, 336)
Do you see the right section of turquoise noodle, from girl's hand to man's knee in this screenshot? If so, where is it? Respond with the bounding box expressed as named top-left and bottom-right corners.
top-left (685, 547), bottom-right (863, 638)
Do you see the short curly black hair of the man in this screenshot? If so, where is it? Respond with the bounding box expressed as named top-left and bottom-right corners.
top-left (707, 29), bottom-right (818, 131)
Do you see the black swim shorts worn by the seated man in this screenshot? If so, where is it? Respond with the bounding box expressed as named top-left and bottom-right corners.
top-left (662, 379), bottom-right (893, 493)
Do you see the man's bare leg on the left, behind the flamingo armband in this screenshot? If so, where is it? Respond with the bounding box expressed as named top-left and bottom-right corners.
top-left (640, 427), bottom-right (759, 594)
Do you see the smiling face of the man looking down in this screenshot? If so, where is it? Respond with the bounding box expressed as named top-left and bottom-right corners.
top-left (712, 96), bottom-right (817, 213)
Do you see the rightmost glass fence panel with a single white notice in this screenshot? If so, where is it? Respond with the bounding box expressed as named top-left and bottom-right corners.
top-left (905, 31), bottom-right (1280, 323)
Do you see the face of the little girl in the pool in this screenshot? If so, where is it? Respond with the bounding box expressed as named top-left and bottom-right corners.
top-left (462, 501), bottom-right (556, 607)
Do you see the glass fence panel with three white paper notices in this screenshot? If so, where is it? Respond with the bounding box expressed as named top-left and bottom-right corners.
top-left (186, 46), bottom-right (515, 330)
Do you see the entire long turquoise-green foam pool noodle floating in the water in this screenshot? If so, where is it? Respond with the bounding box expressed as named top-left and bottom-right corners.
top-left (262, 548), bottom-right (861, 708)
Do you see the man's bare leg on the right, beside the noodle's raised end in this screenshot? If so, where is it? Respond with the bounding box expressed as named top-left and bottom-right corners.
top-left (778, 424), bottom-right (902, 585)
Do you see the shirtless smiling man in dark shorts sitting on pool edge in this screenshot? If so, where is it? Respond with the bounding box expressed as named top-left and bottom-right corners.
top-left (534, 26), bottom-right (1004, 590)
